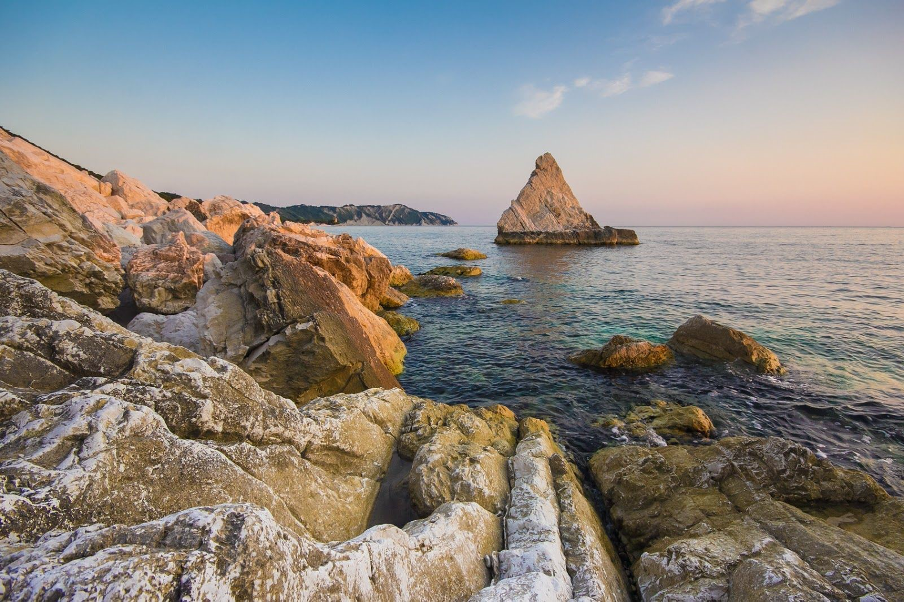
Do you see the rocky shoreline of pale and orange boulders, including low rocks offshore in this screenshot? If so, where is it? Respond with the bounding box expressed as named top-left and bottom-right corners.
top-left (0, 131), bottom-right (904, 602)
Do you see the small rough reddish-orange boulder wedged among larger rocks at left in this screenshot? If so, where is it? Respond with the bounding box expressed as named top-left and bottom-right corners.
top-left (126, 232), bottom-right (205, 314)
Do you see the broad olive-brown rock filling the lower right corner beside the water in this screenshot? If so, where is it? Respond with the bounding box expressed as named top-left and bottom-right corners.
top-left (590, 437), bottom-right (904, 600)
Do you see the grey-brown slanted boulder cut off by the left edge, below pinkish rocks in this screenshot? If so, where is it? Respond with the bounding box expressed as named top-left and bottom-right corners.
top-left (0, 153), bottom-right (123, 312)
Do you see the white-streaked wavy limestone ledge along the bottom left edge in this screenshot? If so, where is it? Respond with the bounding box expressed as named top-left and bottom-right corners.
top-left (0, 504), bottom-right (502, 602)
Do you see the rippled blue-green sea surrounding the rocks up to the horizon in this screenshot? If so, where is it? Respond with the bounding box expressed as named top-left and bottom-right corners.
top-left (329, 227), bottom-right (904, 495)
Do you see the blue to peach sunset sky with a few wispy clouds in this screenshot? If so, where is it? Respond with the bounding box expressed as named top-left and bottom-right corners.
top-left (0, 0), bottom-right (904, 226)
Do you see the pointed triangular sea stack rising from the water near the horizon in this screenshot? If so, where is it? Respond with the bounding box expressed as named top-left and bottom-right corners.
top-left (496, 153), bottom-right (638, 245)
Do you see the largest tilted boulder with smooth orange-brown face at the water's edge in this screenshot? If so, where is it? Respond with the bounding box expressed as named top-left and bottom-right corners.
top-left (129, 247), bottom-right (405, 404)
